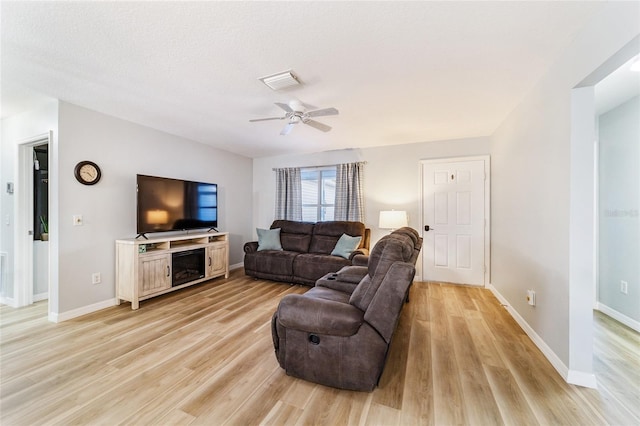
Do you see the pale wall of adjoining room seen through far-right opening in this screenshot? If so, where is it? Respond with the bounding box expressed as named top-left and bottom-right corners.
top-left (594, 55), bottom-right (640, 331)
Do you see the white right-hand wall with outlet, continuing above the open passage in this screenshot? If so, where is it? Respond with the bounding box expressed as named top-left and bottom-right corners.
top-left (491, 2), bottom-right (640, 384)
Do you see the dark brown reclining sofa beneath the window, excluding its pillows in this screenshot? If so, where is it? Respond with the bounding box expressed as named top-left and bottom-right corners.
top-left (244, 220), bottom-right (370, 286)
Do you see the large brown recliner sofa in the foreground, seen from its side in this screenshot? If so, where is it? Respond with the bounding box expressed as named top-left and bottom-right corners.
top-left (271, 228), bottom-right (422, 391)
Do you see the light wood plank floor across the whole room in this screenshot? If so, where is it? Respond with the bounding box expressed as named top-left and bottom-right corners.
top-left (0, 270), bottom-right (640, 426)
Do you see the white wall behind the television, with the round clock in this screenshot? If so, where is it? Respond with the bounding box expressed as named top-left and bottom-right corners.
top-left (59, 102), bottom-right (252, 312)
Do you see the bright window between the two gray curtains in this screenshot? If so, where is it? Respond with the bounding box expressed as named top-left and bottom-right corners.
top-left (300, 167), bottom-right (336, 222)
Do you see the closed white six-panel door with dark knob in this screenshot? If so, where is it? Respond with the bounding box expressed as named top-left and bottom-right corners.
top-left (423, 159), bottom-right (488, 285)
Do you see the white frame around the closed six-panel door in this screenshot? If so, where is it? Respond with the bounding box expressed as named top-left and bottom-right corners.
top-left (419, 155), bottom-right (491, 288)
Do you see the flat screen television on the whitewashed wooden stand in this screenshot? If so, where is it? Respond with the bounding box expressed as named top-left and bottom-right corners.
top-left (136, 175), bottom-right (218, 236)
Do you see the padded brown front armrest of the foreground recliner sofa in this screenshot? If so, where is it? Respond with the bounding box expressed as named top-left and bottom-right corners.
top-left (278, 294), bottom-right (364, 336)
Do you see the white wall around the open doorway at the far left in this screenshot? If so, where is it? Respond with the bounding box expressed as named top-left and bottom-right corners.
top-left (0, 99), bottom-right (58, 304)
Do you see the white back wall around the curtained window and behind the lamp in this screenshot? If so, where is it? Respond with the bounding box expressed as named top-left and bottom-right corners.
top-left (253, 138), bottom-right (489, 275)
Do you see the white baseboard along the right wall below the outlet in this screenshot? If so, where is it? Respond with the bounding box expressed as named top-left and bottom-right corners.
top-left (489, 284), bottom-right (596, 388)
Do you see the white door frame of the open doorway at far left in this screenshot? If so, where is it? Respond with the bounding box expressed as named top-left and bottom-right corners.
top-left (13, 131), bottom-right (53, 307)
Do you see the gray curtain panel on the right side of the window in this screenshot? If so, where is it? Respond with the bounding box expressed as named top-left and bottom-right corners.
top-left (334, 163), bottom-right (365, 222)
